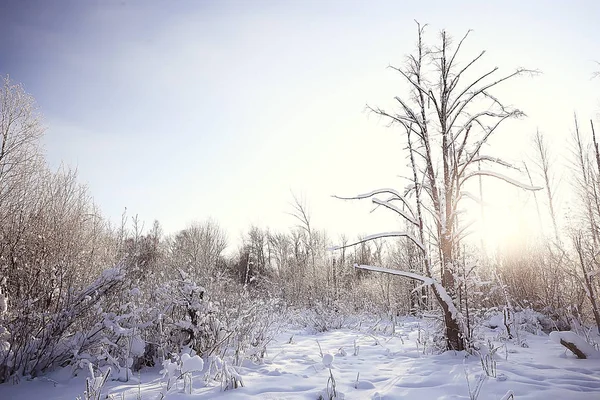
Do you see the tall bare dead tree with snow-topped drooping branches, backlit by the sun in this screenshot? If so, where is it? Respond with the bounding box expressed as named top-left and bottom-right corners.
top-left (332, 23), bottom-right (541, 350)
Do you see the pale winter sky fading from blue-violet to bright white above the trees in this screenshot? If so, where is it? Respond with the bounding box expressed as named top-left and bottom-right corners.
top-left (0, 0), bottom-right (600, 250)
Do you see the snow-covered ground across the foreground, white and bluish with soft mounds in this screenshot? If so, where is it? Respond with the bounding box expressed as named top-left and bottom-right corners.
top-left (0, 319), bottom-right (600, 400)
